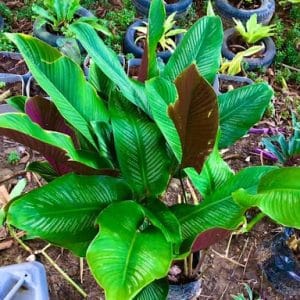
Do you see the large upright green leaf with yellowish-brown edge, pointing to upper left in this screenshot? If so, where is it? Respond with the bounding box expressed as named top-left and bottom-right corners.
top-left (7, 34), bottom-right (108, 147)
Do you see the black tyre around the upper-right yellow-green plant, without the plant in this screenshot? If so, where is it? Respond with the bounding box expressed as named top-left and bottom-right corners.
top-left (222, 28), bottom-right (276, 71)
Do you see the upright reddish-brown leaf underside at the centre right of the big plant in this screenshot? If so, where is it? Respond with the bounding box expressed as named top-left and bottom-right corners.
top-left (168, 64), bottom-right (219, 172)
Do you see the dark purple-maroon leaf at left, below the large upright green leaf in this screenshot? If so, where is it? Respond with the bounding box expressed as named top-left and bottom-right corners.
top-left (25, 96), bottom-right (78, 146)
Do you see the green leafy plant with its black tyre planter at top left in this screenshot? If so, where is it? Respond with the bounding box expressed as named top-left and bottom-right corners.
top-left (32, 0), bottom-right (110, 52)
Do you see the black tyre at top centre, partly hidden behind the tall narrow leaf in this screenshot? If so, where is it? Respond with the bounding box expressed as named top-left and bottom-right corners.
top-left (132, 0), bottom-right (193, 18)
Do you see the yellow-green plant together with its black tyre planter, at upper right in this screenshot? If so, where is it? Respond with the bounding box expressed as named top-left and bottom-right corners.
top-left (222, 14), bottom-right (276, 70)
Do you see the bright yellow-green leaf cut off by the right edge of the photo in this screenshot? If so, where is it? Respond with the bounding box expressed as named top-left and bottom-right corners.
top-left (233, 167), bottom-right (300, 229)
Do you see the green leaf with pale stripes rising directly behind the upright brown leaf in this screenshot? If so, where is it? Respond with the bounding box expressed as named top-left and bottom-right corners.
top-left (162, 16), bottom-right (223, 83)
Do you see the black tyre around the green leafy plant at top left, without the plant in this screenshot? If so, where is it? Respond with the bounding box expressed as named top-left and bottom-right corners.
top-left (33, 7), bottom-right (94, 53)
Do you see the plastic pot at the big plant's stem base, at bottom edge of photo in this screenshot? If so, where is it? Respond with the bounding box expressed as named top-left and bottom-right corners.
top-left (167, 279), bottom-right (202, 300)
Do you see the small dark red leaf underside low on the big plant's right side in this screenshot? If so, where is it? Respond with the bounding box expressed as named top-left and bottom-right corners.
top-left (192, 228), bottom-right (231, 252)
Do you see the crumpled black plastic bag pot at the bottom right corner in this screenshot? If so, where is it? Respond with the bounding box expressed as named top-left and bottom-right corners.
top-left (260, 230), bottom-right (300, 296)
